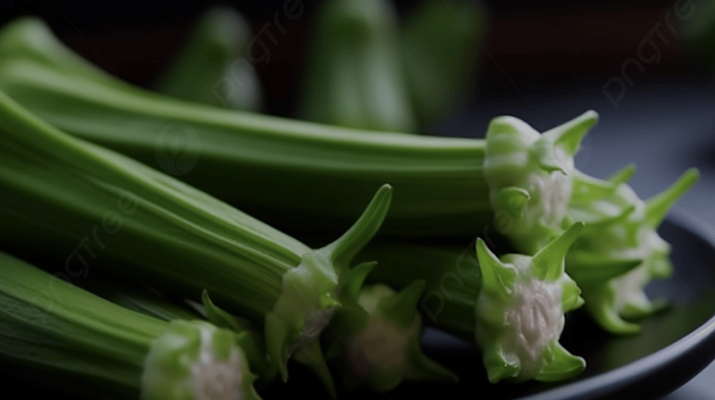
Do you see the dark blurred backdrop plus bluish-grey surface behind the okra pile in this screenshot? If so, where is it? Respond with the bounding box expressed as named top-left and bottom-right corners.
top-left (0, 0), bottom-right (715, 400)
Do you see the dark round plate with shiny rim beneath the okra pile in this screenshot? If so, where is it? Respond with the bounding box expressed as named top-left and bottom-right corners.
top-left (0, 212), bottom-right (715, 400)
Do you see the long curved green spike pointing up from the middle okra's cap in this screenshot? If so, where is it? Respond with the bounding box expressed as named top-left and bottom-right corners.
top-left (324, 184), bottom-right (392, 267)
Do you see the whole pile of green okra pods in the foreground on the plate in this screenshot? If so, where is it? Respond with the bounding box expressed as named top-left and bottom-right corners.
top-left (0, 0), bottom-right (698, 400)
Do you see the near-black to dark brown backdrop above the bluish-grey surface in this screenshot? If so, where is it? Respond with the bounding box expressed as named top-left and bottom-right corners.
top-left (0, 0), bottom-right (704, 119)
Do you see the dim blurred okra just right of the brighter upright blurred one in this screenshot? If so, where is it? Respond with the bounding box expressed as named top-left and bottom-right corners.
top-left (400, 0), bottom-right (486, 123)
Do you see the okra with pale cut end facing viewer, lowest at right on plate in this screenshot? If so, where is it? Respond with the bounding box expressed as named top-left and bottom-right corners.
top-left (364, 223), bottom-right (585, 382)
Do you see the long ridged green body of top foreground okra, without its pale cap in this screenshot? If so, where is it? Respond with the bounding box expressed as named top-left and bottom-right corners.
top-left (0, 50), bottom-right (492, 236)
